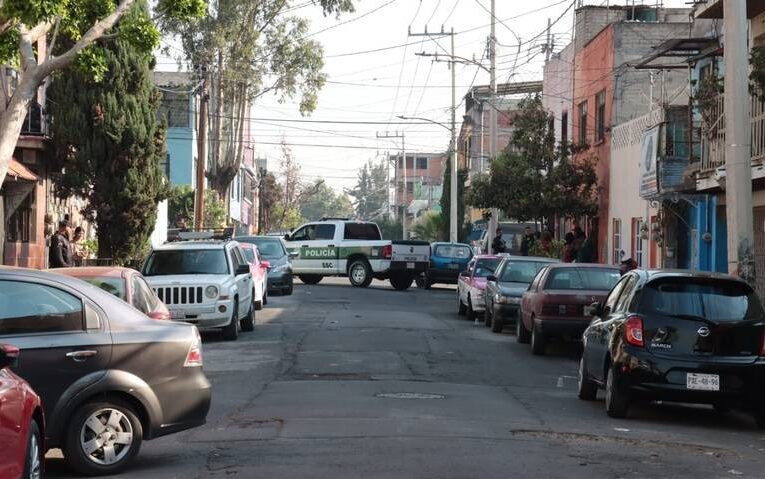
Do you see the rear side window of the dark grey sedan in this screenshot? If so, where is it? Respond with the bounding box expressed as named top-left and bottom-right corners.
top-left (0, 281), bottom-right (84, 335)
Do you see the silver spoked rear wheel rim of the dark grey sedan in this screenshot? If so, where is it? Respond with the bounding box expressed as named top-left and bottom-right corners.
top-left (80, 408), bottom-right (133, 466)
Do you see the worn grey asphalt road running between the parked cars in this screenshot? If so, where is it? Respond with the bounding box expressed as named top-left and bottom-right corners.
top-left (48, 278), bottom-right (765, 479)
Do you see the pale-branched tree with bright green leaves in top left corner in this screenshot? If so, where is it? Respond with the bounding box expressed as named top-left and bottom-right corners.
top-left (0, 0), bottom-right (205, 185)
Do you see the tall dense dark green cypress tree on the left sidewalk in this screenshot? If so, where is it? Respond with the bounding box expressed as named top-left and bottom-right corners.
top-left (49, 1), bottom-right (167, 262)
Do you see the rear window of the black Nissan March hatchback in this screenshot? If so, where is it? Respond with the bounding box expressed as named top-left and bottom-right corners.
top-left (639, 277), bottom-right (763, 322)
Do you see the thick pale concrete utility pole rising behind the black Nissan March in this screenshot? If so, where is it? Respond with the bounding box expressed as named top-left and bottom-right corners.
top-left (723, 0), bottom-right (756, 286)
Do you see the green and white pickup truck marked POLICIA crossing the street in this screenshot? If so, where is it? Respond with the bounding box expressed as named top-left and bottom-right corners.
top-left (284, 218), bottom-right (430, 290)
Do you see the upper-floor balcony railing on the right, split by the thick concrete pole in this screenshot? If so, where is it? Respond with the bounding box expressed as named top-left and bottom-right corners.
top-left (699, 91), bottom-right (765, 175)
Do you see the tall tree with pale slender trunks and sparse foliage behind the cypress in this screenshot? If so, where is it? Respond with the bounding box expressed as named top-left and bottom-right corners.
top-left (163, 0), bottom-right (353, 196)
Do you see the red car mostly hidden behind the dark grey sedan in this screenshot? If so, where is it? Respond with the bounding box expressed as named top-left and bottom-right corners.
top-left (54, 266), bottom-right (170, 319)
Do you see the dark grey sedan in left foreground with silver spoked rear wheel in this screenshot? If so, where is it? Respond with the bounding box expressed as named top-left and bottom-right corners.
top-left (0, 268), bottom-right (211, 475)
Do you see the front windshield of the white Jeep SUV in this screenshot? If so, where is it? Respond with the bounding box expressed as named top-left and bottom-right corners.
top-left (143, 249), bottom-right (228, 276)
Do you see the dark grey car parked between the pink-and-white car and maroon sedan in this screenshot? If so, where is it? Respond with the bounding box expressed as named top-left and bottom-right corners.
top-left (484, 256), bottom-right (558, 333)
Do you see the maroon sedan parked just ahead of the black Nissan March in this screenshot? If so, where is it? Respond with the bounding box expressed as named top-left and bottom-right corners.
top-left (516, 263), bottom-right (620, 354)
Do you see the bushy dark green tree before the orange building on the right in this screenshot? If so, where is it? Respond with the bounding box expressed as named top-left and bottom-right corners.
top-left (467, 95), bottom-right (597, 230)
